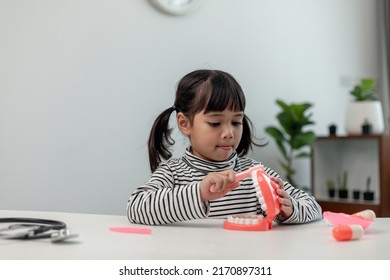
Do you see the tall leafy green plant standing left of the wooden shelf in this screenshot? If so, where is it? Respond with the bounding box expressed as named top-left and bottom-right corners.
top-left (265, 99), bottom-right (316, 189)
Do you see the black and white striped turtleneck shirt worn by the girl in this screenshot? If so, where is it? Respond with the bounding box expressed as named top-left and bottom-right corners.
top-left (127, 150), bottom-right (322, 225)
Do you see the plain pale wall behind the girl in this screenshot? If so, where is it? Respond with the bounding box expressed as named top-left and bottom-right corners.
top-left (0, 0), bottom-right (380, 214)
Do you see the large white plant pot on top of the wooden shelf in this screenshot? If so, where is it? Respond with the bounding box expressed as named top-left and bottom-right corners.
top-left (345, 100), bottom-right (385, 135)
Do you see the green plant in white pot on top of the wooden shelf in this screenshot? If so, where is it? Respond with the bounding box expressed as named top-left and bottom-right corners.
top-left (345, 78), bottom-right (384, 135)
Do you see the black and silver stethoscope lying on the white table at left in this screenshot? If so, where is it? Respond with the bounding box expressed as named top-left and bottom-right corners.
top-left (0, 218), bottom-right (78, 242)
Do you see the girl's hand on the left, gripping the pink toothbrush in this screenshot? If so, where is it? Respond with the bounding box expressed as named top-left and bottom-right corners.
top-left (200, 170), bottom-right (240, 201)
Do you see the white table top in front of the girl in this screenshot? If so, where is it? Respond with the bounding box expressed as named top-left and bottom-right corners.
top-left (0, 210), bottom-right (390, 260)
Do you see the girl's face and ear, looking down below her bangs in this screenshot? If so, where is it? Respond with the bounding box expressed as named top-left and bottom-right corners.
top-left (178, 110), bottom-right (244, 161)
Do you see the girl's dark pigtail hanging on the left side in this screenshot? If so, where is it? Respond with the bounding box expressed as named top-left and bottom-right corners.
top-left (148, 107), bottom-right (175, 172)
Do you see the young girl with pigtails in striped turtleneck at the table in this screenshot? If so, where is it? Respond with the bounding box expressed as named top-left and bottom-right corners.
top-left (127, 70), bottom-right (322, 225)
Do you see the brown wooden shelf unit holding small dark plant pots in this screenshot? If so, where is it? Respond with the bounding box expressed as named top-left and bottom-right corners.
top-left (311, 135), bottom-right (390, 217)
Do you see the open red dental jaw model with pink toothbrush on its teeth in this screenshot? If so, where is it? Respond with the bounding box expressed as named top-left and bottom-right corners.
top-left (223, 165), bottom-right (280, 231)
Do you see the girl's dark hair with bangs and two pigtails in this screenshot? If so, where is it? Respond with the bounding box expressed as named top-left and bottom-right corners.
top-left (148, 70), bottom-right (262, 172)
